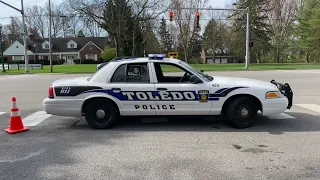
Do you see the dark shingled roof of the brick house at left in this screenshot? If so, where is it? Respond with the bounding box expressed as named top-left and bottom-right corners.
top-left (18, 37), bottom-right (107, 53)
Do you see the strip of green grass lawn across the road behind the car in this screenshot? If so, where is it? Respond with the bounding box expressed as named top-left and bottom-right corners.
top-left (0, 64), bottom-right (320, 75)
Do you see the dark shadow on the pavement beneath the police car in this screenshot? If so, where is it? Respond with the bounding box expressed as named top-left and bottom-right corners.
top-left (72, 113), bottom-right (320, 134)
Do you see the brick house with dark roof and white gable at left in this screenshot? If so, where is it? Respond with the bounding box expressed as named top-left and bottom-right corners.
top-left (3, 35), bottom-right (107, 64)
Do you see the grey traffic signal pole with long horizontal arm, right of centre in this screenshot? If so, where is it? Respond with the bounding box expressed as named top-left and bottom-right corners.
top-left (169, 7), bottom-right (250, 69)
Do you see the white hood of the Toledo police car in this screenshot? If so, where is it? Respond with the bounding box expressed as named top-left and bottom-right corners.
top-left (212, 76), bottom-right (278, 91)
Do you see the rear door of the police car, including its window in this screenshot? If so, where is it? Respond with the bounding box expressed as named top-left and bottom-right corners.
top-left (106, 62), bottom-right (155, 116)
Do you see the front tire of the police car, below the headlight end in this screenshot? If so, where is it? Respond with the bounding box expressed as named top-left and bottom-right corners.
top-left (226, 97), bottom-right (258, 129)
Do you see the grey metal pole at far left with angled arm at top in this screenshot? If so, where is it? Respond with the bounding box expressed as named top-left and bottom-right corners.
top-left (0, 0), bottom-right (29, 73)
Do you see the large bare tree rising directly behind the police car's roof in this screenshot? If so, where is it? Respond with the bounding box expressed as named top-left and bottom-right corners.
top-left (67, 0), bottom-right (169, 56)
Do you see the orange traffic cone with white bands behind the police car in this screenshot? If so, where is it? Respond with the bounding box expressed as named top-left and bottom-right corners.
top-left (5, 97), bottom-right (29, 134)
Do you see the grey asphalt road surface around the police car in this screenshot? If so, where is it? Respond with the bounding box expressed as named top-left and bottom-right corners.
top-left (0, 70), bottom-right (320, 180)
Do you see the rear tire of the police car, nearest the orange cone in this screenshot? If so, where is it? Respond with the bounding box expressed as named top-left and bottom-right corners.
top-left (84, 99), bottom-right (119, 129)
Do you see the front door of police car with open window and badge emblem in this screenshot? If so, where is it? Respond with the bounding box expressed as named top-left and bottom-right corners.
top-left (153, 62), bottom-right (212, 115)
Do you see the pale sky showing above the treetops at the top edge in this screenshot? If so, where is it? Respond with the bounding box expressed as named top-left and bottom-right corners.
top-left (0, 0), bottom-right (233, 25)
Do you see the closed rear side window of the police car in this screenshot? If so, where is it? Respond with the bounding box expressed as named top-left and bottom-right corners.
top-left (111, 63), bottom-right (150, 83)
